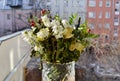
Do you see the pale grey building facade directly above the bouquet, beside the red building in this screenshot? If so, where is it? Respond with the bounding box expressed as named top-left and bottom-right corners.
top-left (46, 0), bottom-right (87, 22)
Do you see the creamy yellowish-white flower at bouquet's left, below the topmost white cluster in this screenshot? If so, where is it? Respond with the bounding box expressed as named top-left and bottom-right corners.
top-left (37, 28), bottom-right (49, 40)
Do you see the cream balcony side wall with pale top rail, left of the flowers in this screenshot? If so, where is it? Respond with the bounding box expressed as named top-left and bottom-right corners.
top-left (0, 32), bottom-right (30, 81)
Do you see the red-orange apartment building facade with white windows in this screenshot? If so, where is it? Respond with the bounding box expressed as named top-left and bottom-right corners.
top-left (87, 0), bottom-right (120, 43)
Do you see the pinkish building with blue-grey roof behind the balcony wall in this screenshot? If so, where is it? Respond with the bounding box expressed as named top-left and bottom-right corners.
top-left (0, 0), bottom-right (44, 36)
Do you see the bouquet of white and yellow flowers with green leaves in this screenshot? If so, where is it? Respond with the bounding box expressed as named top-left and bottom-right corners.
top-left (23, 10), bottom-right (97, 63)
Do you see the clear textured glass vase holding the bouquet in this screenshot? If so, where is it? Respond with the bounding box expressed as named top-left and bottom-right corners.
top-left (42, 61), bottom-right (75, 81)
